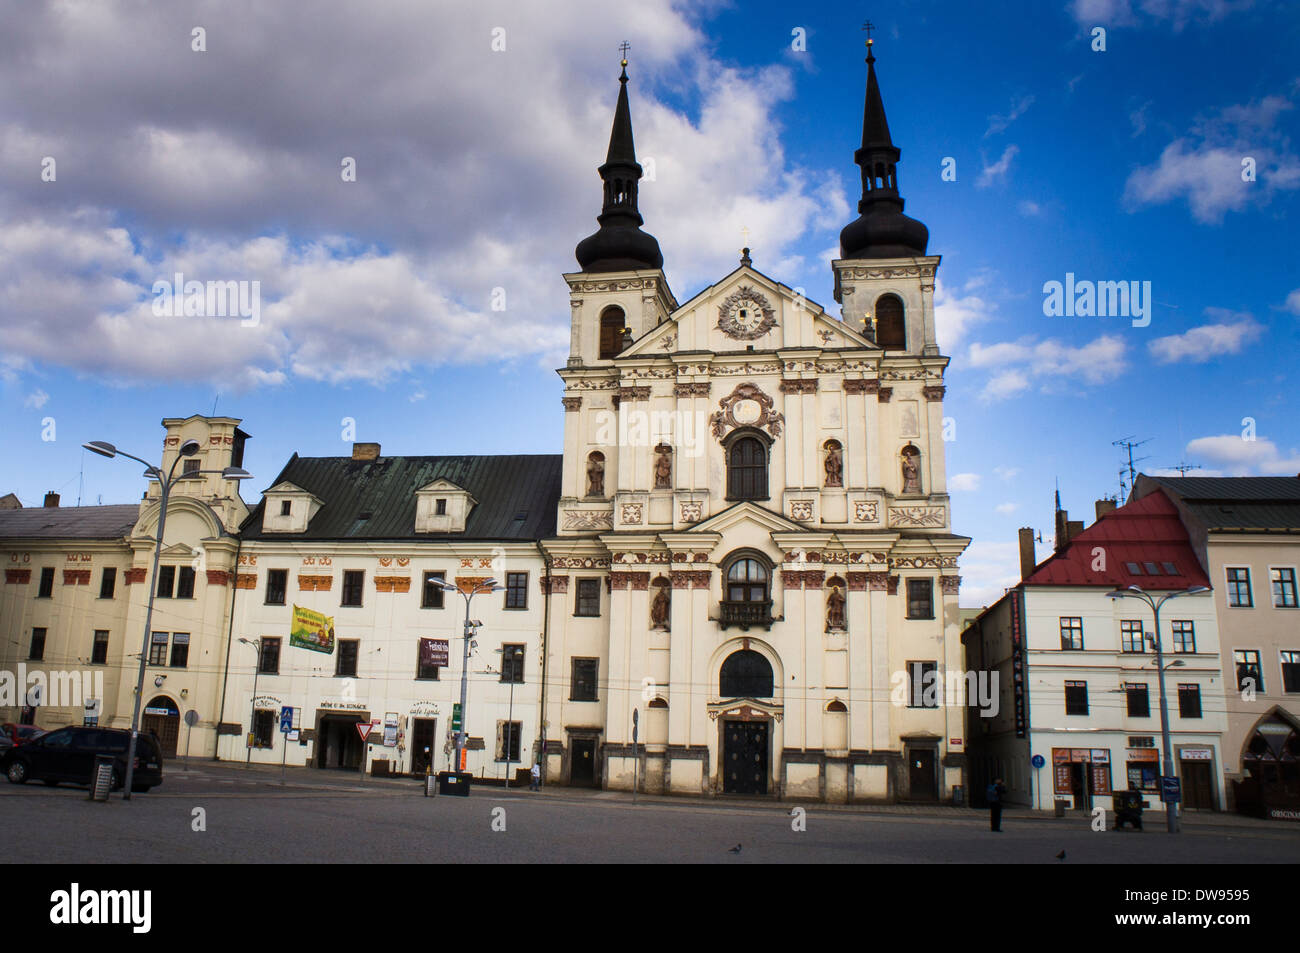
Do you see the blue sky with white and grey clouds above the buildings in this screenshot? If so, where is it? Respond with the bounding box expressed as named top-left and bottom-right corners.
top-left (0, 0), bottom-right (1300, 605)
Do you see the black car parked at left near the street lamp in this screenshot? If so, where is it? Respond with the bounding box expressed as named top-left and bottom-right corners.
top-left (0, 725), bottom-right (163, 793)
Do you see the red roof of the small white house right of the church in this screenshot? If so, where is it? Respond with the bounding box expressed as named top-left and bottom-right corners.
top-left (1024, 490), bottom-right (1210, 590)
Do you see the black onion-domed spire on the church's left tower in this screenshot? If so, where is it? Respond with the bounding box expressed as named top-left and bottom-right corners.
top-left (573, 60), bottom-right (663, 272)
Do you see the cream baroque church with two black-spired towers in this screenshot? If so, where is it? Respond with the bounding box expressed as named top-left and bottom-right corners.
top-left (542, 42), bottom-right (969, 801)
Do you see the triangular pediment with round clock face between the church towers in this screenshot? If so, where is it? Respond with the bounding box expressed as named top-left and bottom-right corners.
top-left (619, 265), bottom-right (876, 360)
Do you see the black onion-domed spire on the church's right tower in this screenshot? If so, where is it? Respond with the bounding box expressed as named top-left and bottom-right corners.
top-left (840, 42), bottom-right (930, 259)
